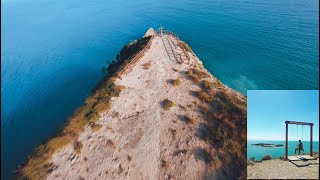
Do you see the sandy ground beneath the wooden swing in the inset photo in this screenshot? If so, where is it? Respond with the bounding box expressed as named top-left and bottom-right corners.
top-left (247, 159), bottom-right (319, 179)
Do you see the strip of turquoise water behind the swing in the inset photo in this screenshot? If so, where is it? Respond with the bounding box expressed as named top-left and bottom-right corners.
top-left (247, 140), bottom-right (319, 160)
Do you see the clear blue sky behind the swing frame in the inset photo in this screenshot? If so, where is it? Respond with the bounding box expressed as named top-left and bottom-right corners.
top-left (247, 90), bottom-right (319, 141)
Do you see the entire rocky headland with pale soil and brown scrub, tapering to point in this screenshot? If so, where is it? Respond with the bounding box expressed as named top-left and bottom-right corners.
top-left (18, 29), bottom-right (246, 179)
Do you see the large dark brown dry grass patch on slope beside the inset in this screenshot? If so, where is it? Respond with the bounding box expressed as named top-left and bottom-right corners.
top-left (195, 80), bottom-right (247, 177)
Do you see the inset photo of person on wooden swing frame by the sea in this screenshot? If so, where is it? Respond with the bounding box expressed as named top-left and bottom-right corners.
top-left (247, 90), bottom-right (319, 179)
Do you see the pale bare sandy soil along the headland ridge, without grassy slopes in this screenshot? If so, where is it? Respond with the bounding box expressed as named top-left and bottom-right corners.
top-left (47, 31), bottom-right (242, 179)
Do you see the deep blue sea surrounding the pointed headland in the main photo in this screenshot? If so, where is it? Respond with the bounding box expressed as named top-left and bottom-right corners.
top-left (1, 0), bottom-right (319, 179)
